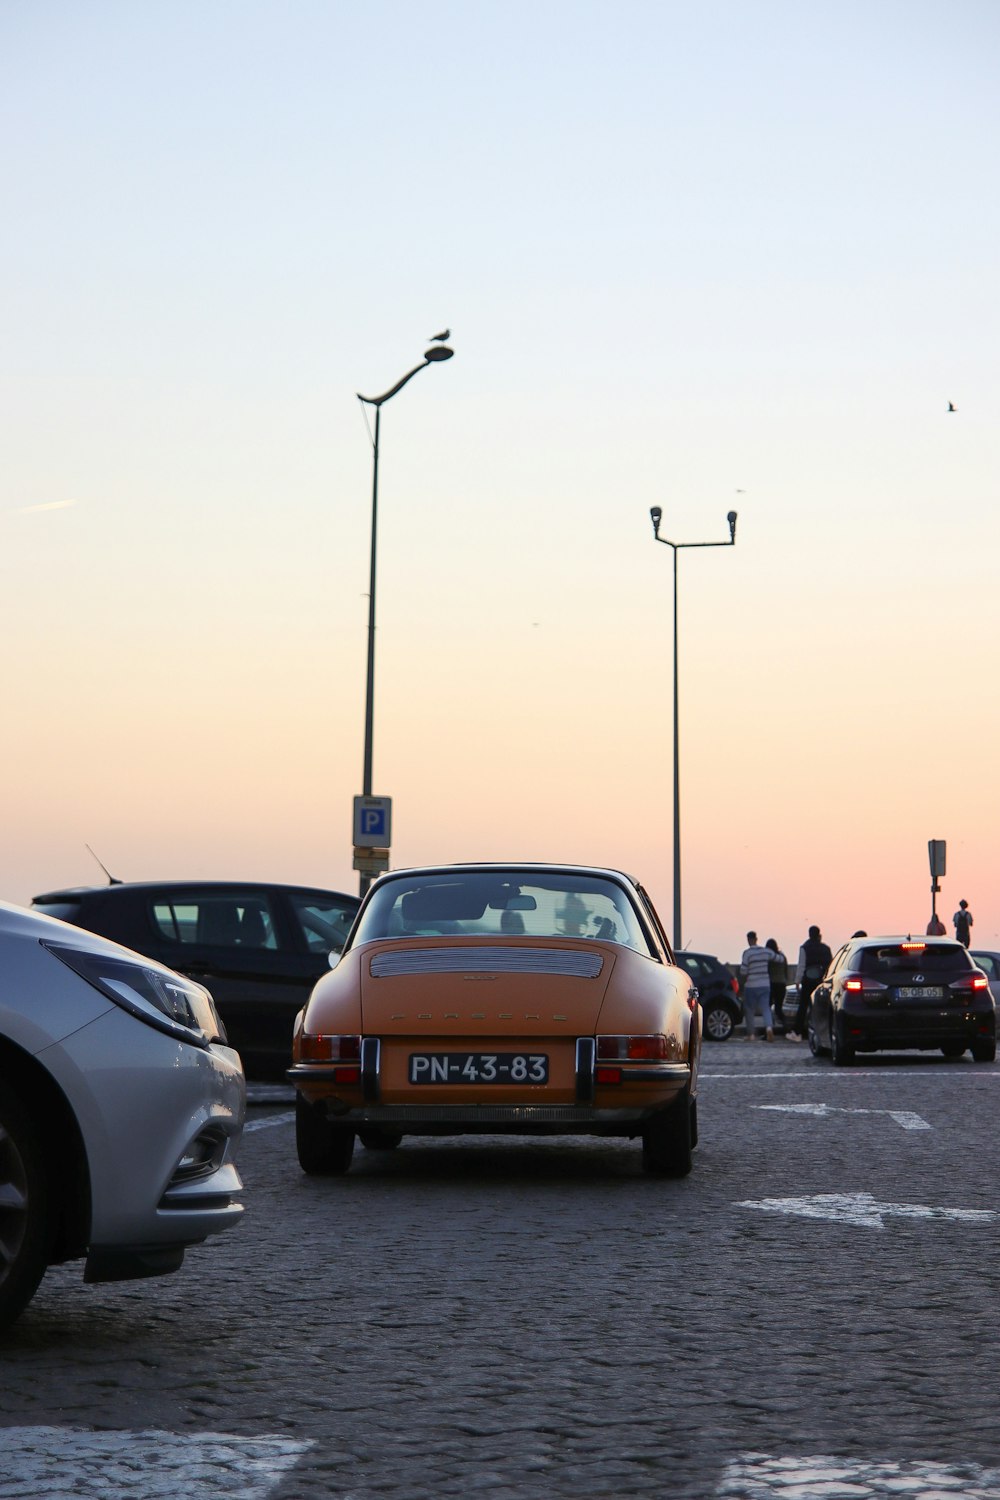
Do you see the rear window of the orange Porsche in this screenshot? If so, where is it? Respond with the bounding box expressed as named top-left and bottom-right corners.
top-left (352, 869), bottom-right (655, 957)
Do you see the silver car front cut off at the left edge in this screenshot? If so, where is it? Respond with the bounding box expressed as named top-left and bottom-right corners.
top-left (0, 903), bottom-right (246, 1328)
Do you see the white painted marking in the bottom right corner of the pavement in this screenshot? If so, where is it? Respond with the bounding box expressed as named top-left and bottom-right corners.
top-left (715, 1454), bottom-right (1000, 1500)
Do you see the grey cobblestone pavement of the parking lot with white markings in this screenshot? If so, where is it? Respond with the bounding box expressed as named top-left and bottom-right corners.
top-left (0, 1040), bottom-right (1000, 1500)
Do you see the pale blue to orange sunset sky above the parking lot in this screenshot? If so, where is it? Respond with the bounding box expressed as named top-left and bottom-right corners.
top-left (0, 0), bottom-right (1000, 959)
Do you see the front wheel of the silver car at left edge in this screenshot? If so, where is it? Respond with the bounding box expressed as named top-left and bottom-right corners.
top-left (0, 1089), bottom-right (52, 1328)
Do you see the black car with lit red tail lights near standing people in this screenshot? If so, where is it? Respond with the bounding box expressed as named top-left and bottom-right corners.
top-left (808, 938), bottom-right (997, 1067)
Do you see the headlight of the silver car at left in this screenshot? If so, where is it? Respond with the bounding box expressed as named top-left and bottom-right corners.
top-left (42, 942), bottom-right (226, 1047)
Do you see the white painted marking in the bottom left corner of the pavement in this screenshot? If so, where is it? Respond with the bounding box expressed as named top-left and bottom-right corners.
top-left (0, 1427), bottom-right (315, 1500)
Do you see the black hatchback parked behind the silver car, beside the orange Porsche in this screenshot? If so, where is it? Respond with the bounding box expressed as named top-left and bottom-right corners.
top-left (31, 881), bottom-right (360, 1079)
